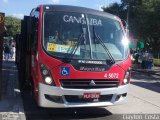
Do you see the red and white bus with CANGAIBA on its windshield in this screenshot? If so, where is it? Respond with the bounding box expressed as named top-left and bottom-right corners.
top-left (17, 5), bottom-right (131, 108)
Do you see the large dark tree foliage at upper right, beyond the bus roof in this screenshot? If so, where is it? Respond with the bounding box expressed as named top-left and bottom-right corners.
top-left (103, 0), bottom-right (160, 51)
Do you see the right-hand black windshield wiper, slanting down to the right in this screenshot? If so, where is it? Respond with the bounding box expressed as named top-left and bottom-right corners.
top-left (93, 26), bottom-right (115, 65)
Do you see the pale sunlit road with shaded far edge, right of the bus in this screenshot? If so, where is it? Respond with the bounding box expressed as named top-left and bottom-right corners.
top-left (107, 72), bottom-right (160, 114)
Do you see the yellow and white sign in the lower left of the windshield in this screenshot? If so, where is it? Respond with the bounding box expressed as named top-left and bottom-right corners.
top-left (47, 43), bottom-right (80, 55)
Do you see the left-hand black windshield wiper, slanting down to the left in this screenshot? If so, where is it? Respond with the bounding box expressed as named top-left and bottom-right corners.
top-left (63, 32), bottom-right (84, 63)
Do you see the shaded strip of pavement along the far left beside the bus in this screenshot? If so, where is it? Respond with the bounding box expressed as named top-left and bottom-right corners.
top-left (0, 61), bottom-right (20, 112)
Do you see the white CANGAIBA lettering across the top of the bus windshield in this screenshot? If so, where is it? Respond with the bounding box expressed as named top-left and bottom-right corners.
top-left (63, 15), bottom-right (102, 26)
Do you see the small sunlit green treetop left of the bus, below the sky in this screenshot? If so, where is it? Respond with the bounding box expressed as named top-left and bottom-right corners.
top-left (5, 16), bottom-right (21, 36)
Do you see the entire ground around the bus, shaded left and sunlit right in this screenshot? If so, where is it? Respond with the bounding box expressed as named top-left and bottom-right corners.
top-left (0, 62), bottom-right (160, 120)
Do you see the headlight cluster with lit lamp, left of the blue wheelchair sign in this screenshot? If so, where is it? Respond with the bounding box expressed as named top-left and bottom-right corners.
top-left (40, 64), bottom-right (55, 85)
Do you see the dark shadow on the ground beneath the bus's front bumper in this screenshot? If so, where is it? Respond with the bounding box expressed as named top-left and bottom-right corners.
top-left (22, 90), bottom-right (112, 120)
